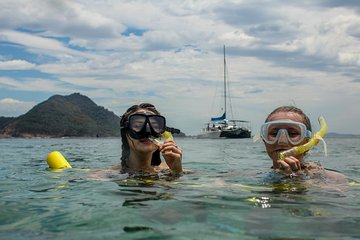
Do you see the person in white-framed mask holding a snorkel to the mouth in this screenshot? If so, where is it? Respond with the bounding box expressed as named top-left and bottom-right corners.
top-left (260, 106), bottom-right (347, 183)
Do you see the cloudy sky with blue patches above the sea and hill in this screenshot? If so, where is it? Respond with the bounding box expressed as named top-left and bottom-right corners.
top-left (0, 0), bottom-right (360, 134)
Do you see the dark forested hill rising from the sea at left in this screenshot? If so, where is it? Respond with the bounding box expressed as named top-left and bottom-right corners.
top-left (0, 93), bottom-right (120, 137)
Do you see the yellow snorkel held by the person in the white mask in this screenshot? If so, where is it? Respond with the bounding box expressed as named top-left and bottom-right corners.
top-left (279, 116), bottom-right (328, 160)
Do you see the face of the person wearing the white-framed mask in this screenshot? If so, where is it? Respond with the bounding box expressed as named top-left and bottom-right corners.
top-left (264, 112), bottom-right (307, 161)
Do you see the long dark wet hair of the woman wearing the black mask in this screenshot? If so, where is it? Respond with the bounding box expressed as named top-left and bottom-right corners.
top-left (120, 103), bottom-right (161, 169)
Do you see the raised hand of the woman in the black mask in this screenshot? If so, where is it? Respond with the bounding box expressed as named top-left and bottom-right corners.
top-left (159, 141), bottom-right (182, 173)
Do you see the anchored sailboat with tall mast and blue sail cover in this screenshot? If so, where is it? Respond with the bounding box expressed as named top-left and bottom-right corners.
top-left (197, 46), bottom-right (251, 139)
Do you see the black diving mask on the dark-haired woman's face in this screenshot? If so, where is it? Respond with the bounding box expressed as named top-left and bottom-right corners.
top-left (125, 113), bottom-right (166, 139)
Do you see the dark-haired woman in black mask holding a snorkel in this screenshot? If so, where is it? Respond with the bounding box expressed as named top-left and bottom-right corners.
top-left (116, 103), bottom-right (182, 174)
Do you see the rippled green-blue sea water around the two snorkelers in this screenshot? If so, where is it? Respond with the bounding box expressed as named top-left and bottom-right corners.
top-left (0, 138), bottom-right (360, 239)
